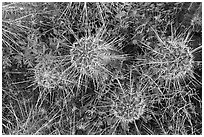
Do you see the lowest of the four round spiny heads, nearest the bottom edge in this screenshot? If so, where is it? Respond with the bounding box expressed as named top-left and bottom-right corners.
top-left (108, 68), bottom-right (146, 123)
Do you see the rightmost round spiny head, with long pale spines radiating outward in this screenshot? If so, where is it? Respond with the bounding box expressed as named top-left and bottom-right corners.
top-left (136, 28), bottom-right (198, 91)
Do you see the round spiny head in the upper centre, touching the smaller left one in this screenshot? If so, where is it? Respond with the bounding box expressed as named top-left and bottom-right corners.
top-left (70, 36), bottom-right (125, 88)
